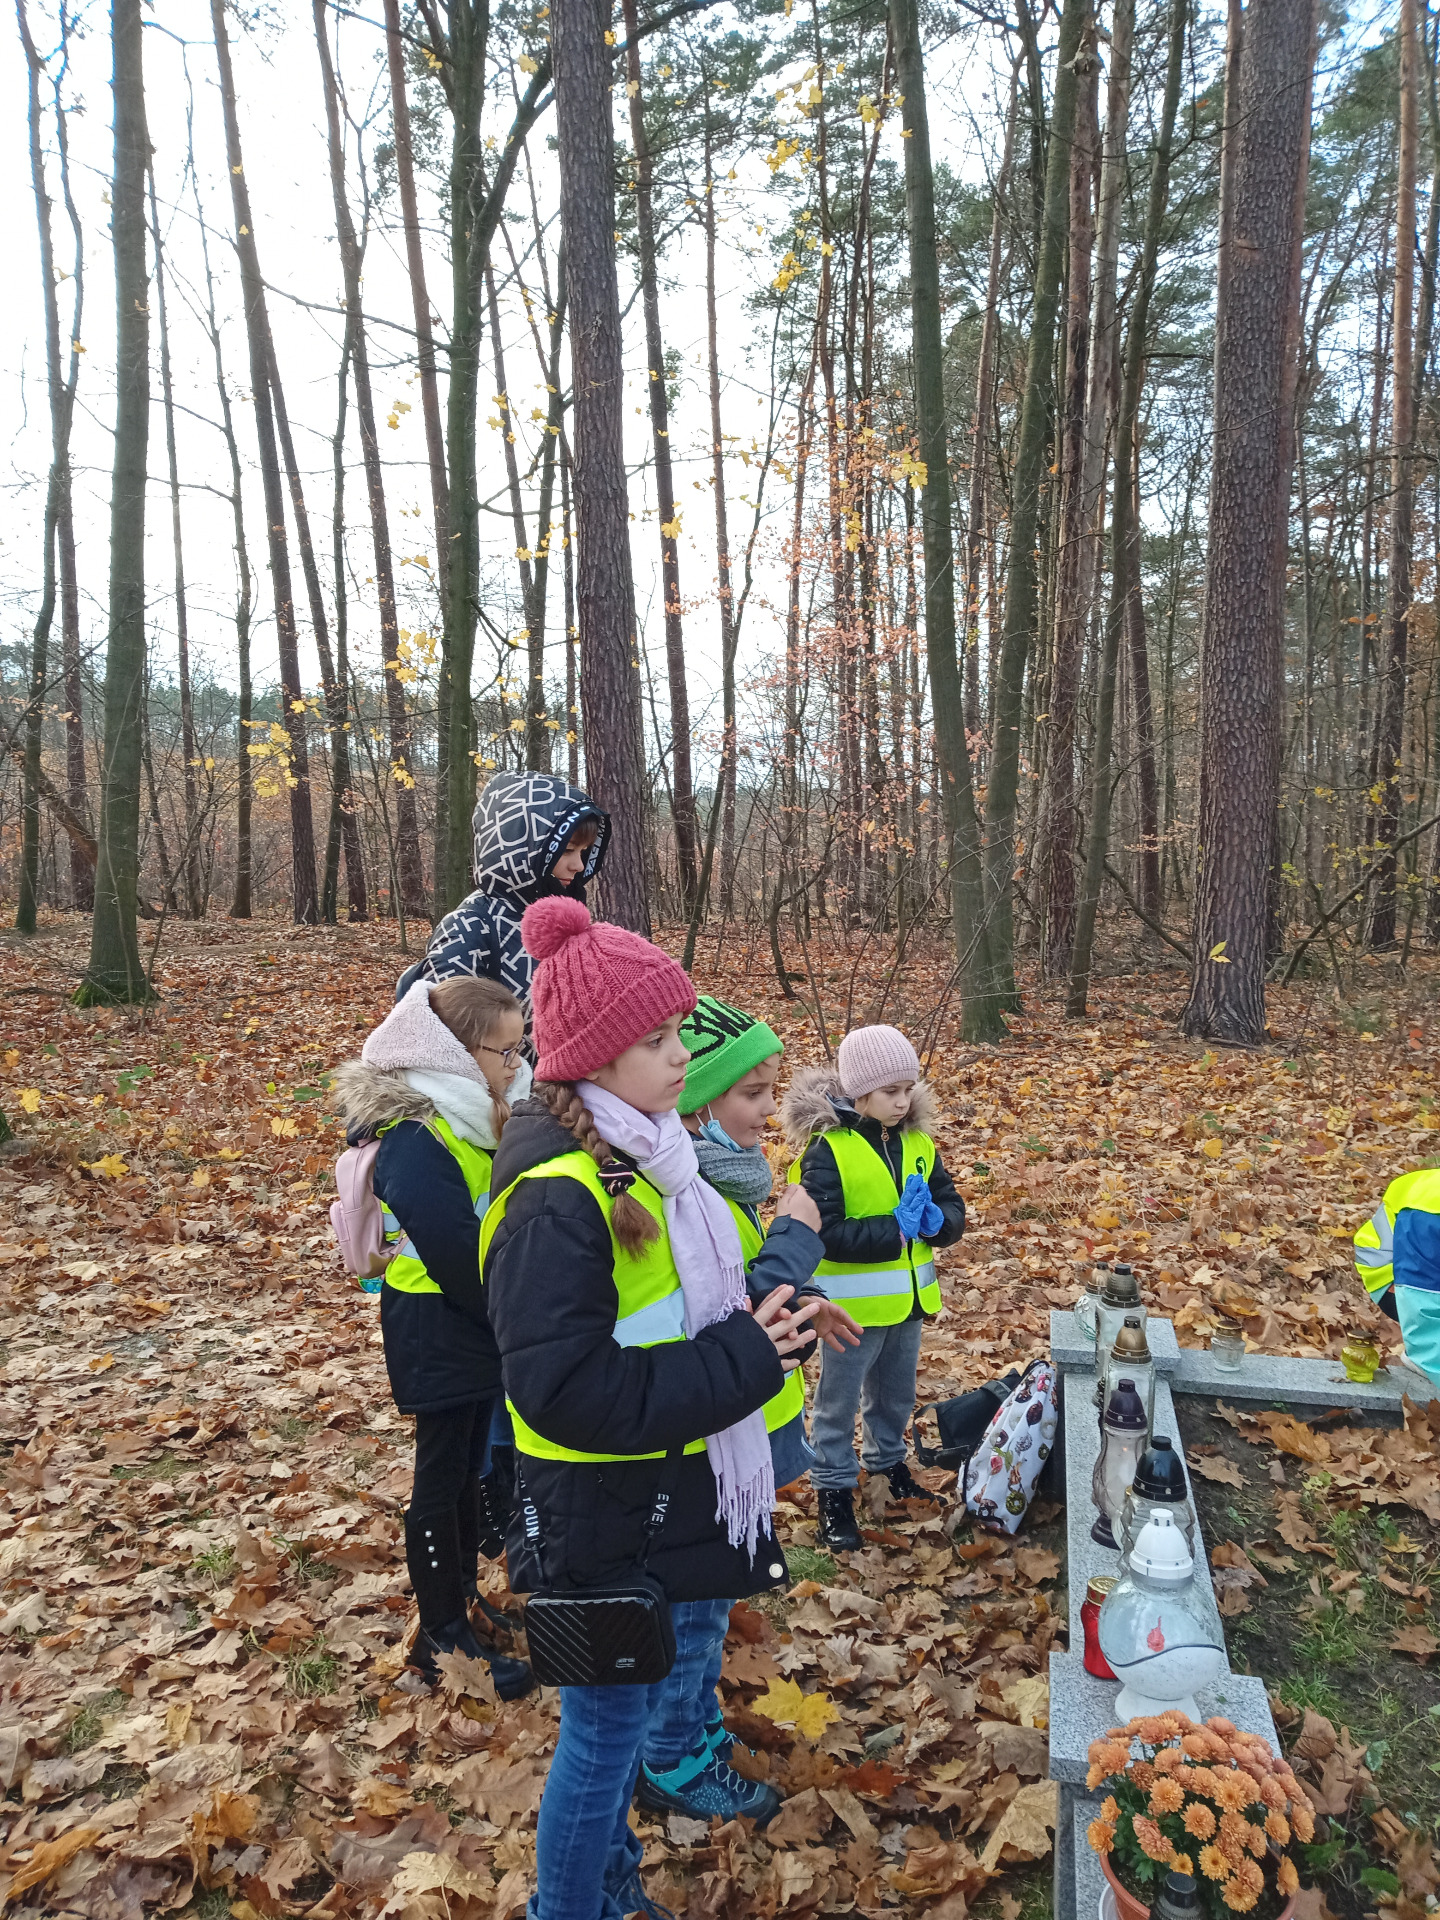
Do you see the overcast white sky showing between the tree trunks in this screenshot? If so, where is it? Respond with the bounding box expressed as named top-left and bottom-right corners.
top-left (0, 0), bottom-right (1029, 771)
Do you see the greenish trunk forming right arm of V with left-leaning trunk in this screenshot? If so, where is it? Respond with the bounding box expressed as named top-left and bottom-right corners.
top-left (985, 0), bottom-right (1092, 1010)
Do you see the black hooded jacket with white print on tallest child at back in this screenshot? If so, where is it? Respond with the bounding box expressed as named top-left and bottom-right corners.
top-left (396, 774), bottom-right (611, 1014)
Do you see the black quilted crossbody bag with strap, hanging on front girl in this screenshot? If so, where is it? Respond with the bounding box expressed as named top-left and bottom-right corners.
top-left (515, 1448), bottom-right (684, 1686)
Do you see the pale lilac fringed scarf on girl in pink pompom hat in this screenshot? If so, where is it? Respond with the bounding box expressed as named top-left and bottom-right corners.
top-left (578, 1081), bottom-right (776, 1557)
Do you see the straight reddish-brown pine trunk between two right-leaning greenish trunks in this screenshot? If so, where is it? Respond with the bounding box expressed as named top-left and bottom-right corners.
top-left (1039, 23), bottom-right (1100, 979)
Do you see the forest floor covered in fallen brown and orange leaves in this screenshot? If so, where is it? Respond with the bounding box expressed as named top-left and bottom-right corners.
top-left (0, 918), bottom-right (1440, 1920)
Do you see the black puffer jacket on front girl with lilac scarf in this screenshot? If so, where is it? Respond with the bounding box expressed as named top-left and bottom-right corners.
top-left (484, 1100), bottom-right (785, 1601)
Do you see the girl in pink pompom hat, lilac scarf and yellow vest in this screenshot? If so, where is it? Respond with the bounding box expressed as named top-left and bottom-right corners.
top-left (482, 899), bottom-right (818, 1920)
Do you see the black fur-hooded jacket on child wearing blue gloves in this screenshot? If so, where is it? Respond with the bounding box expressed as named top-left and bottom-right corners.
top-left (781, 1068), bottom-right (966, 1319)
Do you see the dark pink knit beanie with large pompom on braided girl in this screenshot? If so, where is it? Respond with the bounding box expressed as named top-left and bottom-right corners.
top-left (520, 895), bottom-right (695, 1081)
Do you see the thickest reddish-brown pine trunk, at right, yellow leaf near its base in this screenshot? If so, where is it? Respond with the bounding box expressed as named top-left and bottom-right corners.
top-left (1183, 0), bottom-right (1315, 1046)
